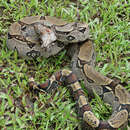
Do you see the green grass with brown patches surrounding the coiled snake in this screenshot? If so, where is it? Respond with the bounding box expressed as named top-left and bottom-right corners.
top-left (0, 0), bottom-right (130, 130)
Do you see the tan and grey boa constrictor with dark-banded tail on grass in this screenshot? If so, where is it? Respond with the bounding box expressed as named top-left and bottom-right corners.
top-left (7, 16), bottom-right (130, 129)
